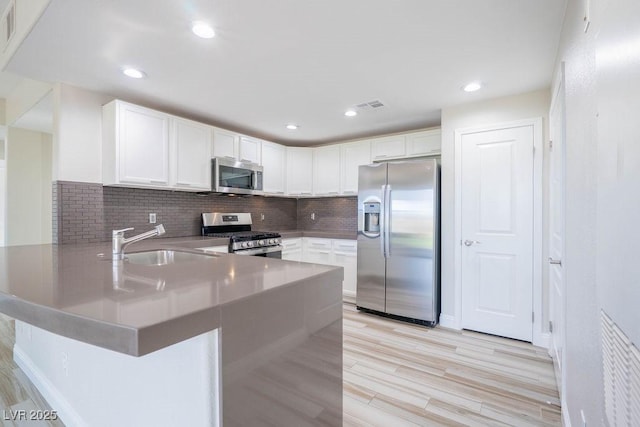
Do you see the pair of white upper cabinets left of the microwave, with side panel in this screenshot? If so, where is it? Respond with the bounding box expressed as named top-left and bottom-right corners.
top-left (102, 100), bottom-right (211, 191)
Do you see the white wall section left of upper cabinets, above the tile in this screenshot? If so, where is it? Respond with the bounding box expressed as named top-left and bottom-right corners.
top-left (53, 84), bottom-right (113, 183)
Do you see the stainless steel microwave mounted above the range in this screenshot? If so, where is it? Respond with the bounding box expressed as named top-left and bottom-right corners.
top-left (211, 157), bottom-right (262, 194)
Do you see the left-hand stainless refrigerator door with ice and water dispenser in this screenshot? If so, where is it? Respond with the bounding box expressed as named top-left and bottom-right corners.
top-left (356, 163), bottom-right (387, 311)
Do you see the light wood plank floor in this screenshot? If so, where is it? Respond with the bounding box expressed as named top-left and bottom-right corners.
top-left (0, 304), bottom-right (561, 427)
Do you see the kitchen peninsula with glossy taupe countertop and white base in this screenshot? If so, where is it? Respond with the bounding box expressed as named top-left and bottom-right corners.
top-left (0, 237), bottom-right (343, 426)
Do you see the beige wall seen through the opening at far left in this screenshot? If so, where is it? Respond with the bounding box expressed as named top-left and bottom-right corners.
top-left (5, 127), bottom-right (52, 246)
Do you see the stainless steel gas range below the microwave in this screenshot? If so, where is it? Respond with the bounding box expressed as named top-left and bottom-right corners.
top-left (202, 212), bottom-right (282, 258)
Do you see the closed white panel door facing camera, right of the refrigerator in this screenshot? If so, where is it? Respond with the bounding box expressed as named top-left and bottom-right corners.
top-left (460, 125), bottom-right (534, 341)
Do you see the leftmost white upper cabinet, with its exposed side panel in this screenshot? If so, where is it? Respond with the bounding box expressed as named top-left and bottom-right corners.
top-left (102, 100), bottom-right (169, 188)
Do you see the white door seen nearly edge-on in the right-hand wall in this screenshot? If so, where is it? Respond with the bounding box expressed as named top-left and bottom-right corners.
top-left (549, 69), bottom-right (566, 396)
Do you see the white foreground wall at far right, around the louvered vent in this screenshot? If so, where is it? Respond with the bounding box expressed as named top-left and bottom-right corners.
top-left (556, 0), bottom-right (640, 426)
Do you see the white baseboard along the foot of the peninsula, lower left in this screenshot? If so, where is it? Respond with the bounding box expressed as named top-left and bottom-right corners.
top-left (13, 344), bottom-right (86, 426)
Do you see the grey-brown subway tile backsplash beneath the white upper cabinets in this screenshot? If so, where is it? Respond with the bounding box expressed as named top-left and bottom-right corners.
top-left (53, 181), bottom-right (357, 244)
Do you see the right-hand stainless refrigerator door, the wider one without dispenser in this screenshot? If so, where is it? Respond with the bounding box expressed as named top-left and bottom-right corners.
top-left (382, 160), bottom-right (438, 322)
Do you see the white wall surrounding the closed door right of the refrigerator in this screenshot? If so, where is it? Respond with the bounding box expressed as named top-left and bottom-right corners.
top-left (440, 89), bottom-right (550, 324)
